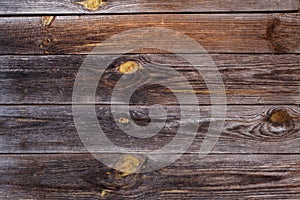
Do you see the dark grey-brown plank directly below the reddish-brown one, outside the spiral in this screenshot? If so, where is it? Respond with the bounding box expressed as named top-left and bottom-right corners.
top-left (0, 54), bottom-right (300, 105)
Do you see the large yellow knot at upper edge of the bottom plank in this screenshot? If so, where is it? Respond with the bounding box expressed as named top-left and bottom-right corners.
top-left (114, 155), bottom-right (141, 177)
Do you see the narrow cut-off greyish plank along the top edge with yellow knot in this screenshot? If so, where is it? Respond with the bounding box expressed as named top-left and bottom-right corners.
top-left (0, 0), bottom-right (299, 15)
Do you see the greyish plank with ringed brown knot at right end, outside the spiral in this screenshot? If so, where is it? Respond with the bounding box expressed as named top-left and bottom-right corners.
top-left (0, 106), bottom-right (300, 153)
